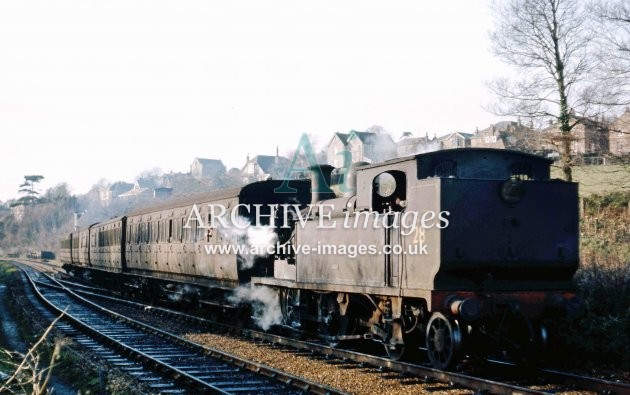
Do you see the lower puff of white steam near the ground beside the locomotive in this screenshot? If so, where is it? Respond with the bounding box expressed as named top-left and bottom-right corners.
top-left (228, 285), bottom-right (282, 330)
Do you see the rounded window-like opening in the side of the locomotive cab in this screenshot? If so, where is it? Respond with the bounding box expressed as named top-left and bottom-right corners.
top-left (372, 170), bottom-right (407, 213)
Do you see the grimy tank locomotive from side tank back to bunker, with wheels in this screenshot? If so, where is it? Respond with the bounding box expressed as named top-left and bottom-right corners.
top-left (254, 148), bottom-right (582, 368)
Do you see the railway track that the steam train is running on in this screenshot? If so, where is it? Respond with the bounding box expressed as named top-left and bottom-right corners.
top-left (50, 272), bottom-right (630, 394)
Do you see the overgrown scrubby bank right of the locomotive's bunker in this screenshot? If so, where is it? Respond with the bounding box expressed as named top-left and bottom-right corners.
top-left (553, 192), bottom-right (630, 374)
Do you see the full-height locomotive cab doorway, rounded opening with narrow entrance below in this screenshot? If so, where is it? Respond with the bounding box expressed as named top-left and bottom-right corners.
top-left (372, 170), bottom-right (407, 287)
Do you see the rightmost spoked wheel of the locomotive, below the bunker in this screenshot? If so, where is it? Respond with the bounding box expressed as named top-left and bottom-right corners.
top-left (426, 313), bottom-right (462, 370)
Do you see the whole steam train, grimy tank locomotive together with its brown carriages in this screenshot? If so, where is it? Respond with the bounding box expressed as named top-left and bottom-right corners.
top-left (60, 148), bottom-right (584, 369)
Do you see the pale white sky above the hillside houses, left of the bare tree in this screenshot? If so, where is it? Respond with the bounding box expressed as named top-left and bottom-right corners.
top-left (0, 0), bottom-right (505, 201)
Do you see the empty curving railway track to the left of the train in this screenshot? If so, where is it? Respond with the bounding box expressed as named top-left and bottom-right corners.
top-left (14, 265), bottom-right (348, 394)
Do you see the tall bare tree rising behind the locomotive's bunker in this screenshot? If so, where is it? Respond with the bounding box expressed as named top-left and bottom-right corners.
top-left (490, 0), bottom-right (620, 181)
